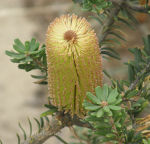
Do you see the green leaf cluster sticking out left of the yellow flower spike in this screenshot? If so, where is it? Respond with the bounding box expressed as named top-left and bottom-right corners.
top-left (6, 38), bottom-right (47, 84)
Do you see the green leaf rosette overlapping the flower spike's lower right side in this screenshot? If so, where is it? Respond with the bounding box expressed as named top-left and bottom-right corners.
top-left (83, 84), bottom-right (127, 142)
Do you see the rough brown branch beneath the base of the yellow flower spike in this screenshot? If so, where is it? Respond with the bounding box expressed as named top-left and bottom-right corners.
top-left (21, 112), bottom-right (93, 144)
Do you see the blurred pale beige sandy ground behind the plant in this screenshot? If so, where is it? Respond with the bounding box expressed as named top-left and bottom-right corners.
top-left (0, 0), bottom-right (150, 144)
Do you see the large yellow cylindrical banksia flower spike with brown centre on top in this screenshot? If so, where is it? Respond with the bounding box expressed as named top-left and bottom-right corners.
top-left (46, 14), bottom-right (102, 116)
